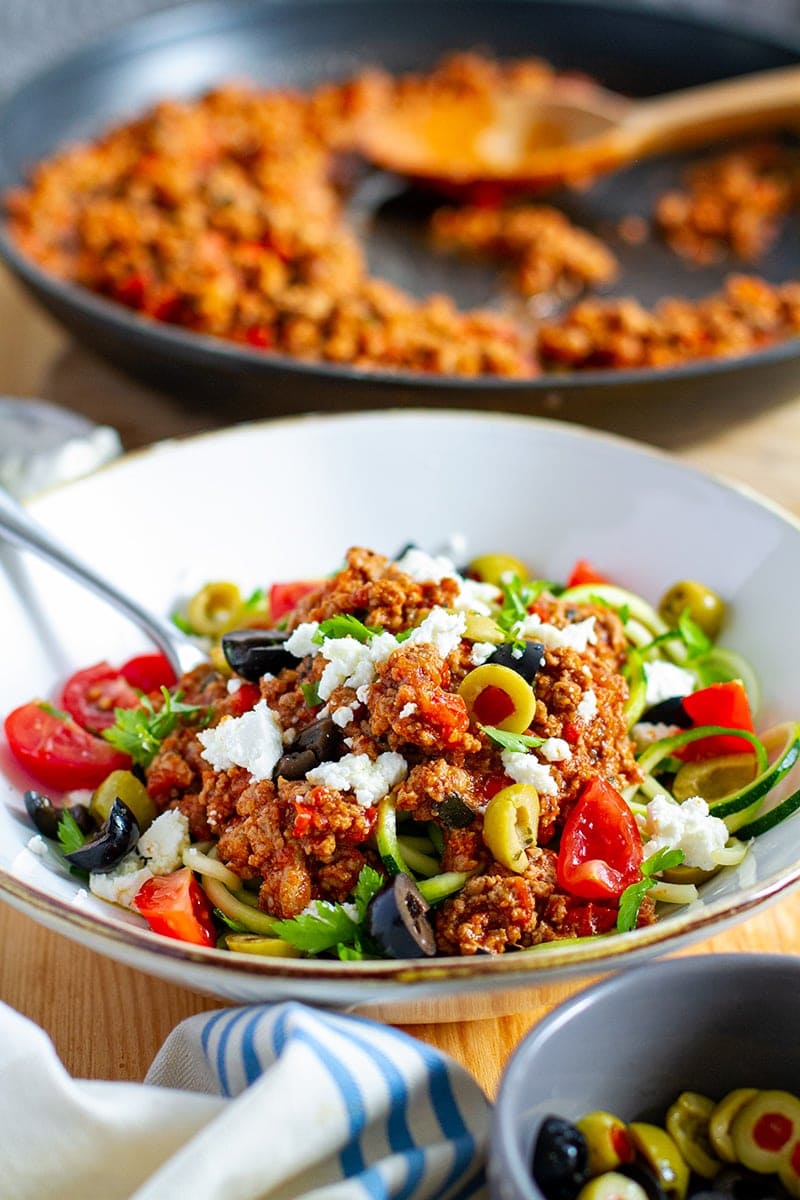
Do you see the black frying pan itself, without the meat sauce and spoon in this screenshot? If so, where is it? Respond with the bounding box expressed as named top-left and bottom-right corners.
top-left (0, 0), bottom-right (800, 424)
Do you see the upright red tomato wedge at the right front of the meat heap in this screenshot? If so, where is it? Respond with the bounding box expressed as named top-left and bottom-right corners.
top-left (557, 779), bottom-right (644, 900)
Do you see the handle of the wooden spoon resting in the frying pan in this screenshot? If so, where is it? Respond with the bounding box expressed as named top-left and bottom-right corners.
top-left (618, 66), bottom-right (800, 151)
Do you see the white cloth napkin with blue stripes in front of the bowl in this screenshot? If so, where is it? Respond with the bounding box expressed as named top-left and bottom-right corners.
top-left (0, 1003), bottom-right (489, 1200)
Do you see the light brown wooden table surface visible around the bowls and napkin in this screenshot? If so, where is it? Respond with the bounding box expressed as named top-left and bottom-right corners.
top-left (0, 267), bottom-right (800, 1096)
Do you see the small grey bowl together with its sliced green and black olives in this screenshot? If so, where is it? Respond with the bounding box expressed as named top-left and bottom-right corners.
top-left (488, 954), bottom-right (800, 1200)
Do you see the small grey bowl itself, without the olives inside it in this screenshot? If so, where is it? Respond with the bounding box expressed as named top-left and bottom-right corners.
top-left (488, 954), bottom-right (800, 1200)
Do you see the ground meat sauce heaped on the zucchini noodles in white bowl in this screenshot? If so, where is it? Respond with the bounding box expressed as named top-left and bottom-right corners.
top-left (140, 548), bottom-right (654, 954)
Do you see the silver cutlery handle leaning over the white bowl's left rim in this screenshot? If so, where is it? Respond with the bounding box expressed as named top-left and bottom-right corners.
top-left (0, 487), bottom-right (207, 676)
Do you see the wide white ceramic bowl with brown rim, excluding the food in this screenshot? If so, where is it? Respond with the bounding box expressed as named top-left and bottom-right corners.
top-left (0, 410), bottom-right (800, 1020)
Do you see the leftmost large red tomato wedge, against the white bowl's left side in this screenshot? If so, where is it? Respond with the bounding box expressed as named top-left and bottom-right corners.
top-left (4, 701), bottom-right (131, 792)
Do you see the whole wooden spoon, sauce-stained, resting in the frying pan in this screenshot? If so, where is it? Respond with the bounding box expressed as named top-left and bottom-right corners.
top-left (360, 66), bottom-right (800, 188)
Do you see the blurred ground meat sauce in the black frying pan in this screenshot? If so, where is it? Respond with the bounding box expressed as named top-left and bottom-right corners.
top-left (5, 54), bottom-right (800, 378)
